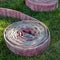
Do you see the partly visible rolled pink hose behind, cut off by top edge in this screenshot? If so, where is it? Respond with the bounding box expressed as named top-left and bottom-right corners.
top-left (25, 0), bottom-right (58, 11)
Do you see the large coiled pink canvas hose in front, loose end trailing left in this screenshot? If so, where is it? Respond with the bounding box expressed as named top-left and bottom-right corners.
top-left (0, 8), bottom-right (50, 56)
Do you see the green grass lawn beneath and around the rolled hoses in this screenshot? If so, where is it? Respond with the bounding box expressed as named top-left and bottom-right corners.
top-left (0, 0), bottom-right (60, 60)
